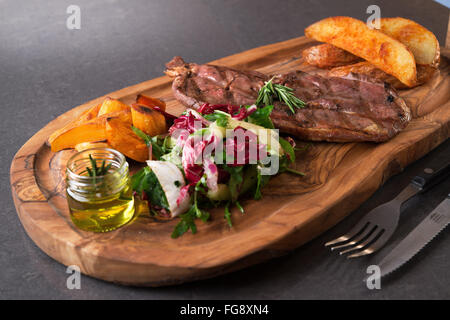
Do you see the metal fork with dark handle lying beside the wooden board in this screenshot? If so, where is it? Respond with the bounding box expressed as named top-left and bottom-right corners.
top-left (325, 158), bottom-right (450, 258)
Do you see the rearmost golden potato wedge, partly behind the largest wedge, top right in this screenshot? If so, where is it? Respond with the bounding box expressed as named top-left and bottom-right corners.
top-left (380, 18), bottom-right (440, 67)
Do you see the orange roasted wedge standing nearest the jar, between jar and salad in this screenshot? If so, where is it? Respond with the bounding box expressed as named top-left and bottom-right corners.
top-left (105, 117), bottom-right (149, 162)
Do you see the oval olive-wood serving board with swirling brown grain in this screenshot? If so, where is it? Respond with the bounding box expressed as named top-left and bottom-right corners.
top-left (11, 37), bottom-right (450, 286)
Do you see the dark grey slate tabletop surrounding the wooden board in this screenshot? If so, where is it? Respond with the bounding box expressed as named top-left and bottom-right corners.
top-left (0, 0), bottom-right (450, 299)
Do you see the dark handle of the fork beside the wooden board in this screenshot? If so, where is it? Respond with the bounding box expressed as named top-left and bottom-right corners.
top-left (412, 157), bottom-right (450, 191)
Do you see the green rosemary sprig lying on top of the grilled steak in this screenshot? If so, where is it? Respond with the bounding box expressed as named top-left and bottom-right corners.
top-left (256, 77), bottom-right (306, 113)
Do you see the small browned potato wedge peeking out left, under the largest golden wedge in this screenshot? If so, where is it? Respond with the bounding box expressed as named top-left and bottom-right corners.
top-left (302, 43), bottom-right (362, 69)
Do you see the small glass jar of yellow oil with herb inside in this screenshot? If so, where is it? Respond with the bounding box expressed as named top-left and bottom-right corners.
top-left (66, 148), bottom-right (134, 232)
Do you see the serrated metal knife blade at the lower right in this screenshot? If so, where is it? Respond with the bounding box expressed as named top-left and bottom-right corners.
top-left (378, 194), bottom-right (450, 277)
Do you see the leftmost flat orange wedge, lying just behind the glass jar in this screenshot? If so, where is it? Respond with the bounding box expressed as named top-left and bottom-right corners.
top-left (50, 118), bottom-right (107, 152)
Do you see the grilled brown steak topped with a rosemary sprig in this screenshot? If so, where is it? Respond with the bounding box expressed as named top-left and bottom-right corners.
top-left (166, 57), bottom-right (411, 142)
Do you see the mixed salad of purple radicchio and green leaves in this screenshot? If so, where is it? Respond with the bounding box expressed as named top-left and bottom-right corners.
top-left (132, 100), bottom-right (303, 238)
